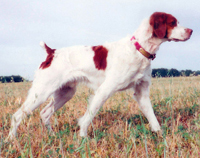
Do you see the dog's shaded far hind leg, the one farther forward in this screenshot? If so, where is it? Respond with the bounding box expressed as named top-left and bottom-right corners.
top-left (40, 85), bottom-right (76, 131)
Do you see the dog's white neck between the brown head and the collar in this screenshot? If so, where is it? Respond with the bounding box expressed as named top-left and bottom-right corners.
top-left (134, 19), bottom-right (167, 54)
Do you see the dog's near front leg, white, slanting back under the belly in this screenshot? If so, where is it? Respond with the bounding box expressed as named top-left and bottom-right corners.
top-left (78, 83), bottom-right (115, 137)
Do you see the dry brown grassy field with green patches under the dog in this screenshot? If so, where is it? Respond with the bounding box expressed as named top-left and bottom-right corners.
top-left (0, 77), bottom-right (200, 158)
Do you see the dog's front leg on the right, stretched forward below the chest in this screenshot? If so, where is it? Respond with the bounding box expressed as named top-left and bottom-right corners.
top-left (133, 81), bottom-right (160, 132)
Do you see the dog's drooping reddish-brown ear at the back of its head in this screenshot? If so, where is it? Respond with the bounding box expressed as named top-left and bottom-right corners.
top-left (149, 12), bottom-right (167, 39)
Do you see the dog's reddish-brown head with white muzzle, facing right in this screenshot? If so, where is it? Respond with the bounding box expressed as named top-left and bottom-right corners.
top-left (149, 12), bottom-right (193, 41)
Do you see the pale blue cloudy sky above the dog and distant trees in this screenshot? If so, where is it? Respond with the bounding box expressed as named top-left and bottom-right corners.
top-left (0, 0), bottom-right (200, 80)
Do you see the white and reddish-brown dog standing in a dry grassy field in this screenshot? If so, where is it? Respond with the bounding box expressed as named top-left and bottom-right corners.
top-left (9, 12), bottom-right (193, 139)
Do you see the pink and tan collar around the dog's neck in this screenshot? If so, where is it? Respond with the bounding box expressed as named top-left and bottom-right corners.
top-left (131, 36), bottom-right (156, 60)
